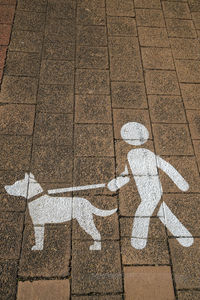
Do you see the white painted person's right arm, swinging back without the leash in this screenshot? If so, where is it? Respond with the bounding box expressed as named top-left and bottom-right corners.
top-left (156, 155), bottom-right (189, 192)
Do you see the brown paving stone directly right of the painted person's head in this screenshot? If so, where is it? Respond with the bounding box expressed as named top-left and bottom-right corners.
top-left (153, 124), bottom-right (193, 155)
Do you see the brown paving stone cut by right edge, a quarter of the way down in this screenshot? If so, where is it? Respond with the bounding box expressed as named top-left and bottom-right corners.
top-left (175, 60), bottom-right (200, 83)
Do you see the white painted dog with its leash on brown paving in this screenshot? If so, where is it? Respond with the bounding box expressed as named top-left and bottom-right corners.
top-left (5, 173), bottom-right (117, 250)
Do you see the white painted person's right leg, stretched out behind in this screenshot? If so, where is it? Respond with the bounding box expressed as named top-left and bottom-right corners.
top-left (158, 202), bottom-right (194, 247)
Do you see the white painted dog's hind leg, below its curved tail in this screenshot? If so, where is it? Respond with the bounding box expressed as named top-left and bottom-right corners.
top-left (76, 214), bottom-right (101, 250)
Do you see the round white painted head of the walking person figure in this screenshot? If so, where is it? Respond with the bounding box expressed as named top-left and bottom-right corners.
top-left (121, 122), bottom-right (149, 146)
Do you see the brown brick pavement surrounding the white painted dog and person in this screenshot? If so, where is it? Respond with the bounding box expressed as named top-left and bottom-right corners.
top-left (0, 0), bottom-right (200, 300)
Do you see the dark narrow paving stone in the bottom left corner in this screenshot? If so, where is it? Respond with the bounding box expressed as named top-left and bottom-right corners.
top-left (0, 260), bottom-right (18, 300)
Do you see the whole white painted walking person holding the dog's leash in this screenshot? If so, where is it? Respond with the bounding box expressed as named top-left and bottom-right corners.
top-left (108, 122), bottom-right (194, 249)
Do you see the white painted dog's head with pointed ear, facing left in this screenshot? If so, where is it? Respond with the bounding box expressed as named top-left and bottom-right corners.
top-left (4, 173), bottom-right (34, 198)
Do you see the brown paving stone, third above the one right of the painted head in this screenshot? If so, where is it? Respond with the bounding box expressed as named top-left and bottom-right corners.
top-left (141, 47), bottom-right (175, 70)
